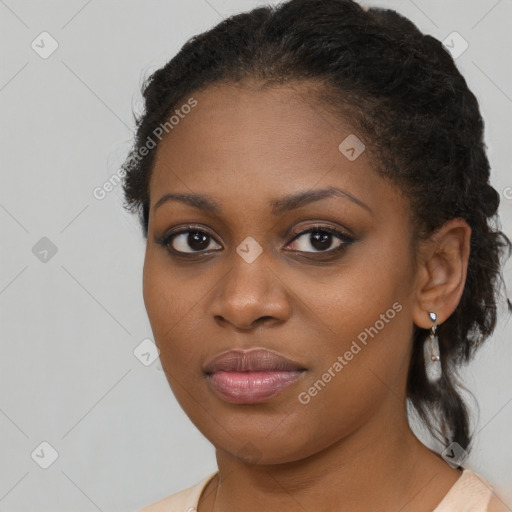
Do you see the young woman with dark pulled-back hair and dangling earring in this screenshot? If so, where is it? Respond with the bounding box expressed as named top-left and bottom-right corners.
top-left (124, 0), bottom-right (510, 512)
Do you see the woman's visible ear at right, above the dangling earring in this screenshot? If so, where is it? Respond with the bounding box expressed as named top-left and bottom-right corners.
top-left (413, 219), bottom-right (471, 329)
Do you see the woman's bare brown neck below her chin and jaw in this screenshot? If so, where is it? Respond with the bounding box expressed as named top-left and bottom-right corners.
top-left (199, 397), bottom-right (460, 512)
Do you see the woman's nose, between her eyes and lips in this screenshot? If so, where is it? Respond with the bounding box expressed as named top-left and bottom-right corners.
top-left (211, 254), bottom-right (291, 330)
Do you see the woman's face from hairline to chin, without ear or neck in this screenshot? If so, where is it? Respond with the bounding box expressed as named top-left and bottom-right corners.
top-left (144, 80), bottom-right (420, 464)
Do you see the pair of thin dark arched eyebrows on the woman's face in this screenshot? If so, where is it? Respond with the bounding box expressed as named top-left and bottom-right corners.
top-left (154, 187), bottom-right (373, 215)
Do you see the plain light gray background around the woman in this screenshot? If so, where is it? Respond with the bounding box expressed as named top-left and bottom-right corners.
top-left (0, 0), bottom-right (512, 512)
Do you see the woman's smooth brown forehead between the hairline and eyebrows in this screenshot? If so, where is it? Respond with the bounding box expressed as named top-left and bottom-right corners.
top-left (146, 82), bottom-right (398, 219)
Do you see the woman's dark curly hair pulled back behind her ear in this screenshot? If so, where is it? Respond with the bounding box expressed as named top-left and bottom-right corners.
top-left (122, 0), bottom-right (511, 451)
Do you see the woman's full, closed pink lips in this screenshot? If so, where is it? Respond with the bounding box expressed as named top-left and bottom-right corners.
top-left (204, 349), bottom-right (305, 404)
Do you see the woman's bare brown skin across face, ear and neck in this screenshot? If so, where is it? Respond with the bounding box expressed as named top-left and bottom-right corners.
top-left (143, 81), bottom-right (470, 512)
